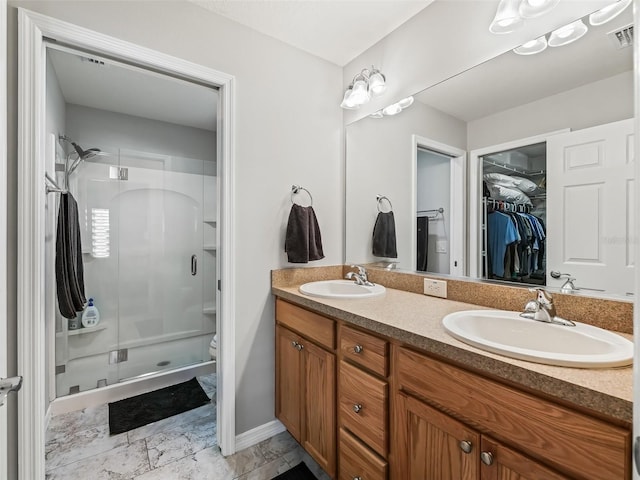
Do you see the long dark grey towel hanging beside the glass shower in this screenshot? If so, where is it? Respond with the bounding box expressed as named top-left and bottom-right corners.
top-left (56, 193), bottom-right (87, 318)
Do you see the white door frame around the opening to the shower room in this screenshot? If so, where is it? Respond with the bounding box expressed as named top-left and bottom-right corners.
top-left (18, 8), bottom-right (236, 480)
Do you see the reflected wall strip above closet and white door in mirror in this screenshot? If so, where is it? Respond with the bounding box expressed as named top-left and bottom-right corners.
top-left (467, 71), bottom-right (633, 150)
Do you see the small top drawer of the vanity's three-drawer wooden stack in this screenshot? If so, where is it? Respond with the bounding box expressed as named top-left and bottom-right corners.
top-left (340, 326), bottom-right (389, 377)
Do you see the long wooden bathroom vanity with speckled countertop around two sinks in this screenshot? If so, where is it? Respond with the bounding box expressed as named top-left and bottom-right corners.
top-left (273, 268), bottom-right (632, 480)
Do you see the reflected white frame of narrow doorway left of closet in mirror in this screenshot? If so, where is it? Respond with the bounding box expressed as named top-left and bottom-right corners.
top-left (411, 135), bottom-right (467, 277)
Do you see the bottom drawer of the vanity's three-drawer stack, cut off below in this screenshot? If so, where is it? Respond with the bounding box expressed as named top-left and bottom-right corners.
top-left (338, 428), bottom-right (387, 480)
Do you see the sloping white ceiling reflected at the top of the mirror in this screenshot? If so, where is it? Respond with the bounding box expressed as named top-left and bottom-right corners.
top-left (415, 8), bottom-right (633, 122)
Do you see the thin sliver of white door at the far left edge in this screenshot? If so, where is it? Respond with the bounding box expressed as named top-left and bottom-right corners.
top-left (0, 0), bottom-right (8, 478)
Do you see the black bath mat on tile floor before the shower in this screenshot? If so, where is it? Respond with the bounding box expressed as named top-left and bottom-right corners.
top-left (109, 377), bottom-right (210, 435)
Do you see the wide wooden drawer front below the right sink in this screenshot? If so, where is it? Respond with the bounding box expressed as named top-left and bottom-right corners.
top-left (393, 348), bottom-right (631, 480)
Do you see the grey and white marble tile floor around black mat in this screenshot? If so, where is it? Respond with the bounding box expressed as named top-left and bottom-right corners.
top-left (46, 374), bottom-right (329, 480)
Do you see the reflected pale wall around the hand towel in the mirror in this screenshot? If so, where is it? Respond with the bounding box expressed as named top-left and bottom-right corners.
top-left (345, 102), bottom-right (467, 270)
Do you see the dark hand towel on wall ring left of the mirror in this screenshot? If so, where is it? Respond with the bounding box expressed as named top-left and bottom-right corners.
top-left (284, 204), bottom-right (324, 263)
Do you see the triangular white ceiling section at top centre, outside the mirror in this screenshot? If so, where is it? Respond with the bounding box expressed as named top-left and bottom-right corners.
top-left (191, 0), bottom-right (433, 67)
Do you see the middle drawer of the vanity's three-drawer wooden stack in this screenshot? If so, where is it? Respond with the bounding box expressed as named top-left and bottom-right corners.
top-left (338, 361), bottom-right (389, 457)
